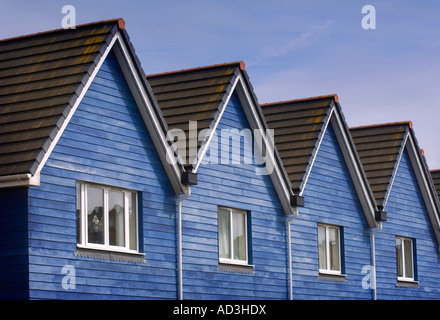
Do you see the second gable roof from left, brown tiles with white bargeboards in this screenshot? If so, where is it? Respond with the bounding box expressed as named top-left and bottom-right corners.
top-left (147, 61), bottom-right (293, 214)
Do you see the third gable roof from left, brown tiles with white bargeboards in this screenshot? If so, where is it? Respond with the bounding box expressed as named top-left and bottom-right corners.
top-left (261, 94), bottom-right (376, 227)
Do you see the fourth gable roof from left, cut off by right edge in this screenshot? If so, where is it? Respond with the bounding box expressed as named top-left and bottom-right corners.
top-left (350, 121), bottom-right (440, 244)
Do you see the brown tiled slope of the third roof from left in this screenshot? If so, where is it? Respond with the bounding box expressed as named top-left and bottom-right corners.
top-left (261, 95), bottom-right (337, 190)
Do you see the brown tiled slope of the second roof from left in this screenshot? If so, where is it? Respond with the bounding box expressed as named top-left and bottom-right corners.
top-left (147, 62), bottom-right (244, 164)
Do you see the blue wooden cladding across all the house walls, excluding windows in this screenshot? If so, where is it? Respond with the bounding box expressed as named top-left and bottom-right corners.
top-left (0, 45), bottom-right (440, 300)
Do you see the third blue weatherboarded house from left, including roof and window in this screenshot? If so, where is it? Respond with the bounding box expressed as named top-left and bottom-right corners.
top-left (262, 95), bottom-right (377, 299)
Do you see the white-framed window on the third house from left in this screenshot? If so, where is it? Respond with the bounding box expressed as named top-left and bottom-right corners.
top-left (318, 224), bottom-right (342, 274)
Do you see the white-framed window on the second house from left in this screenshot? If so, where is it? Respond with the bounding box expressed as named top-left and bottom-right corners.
top-left (218, 208), bottom-right (248, 264)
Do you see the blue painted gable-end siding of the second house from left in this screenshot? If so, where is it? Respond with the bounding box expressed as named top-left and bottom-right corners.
top-left (182, 93), bottom-right (288, 299)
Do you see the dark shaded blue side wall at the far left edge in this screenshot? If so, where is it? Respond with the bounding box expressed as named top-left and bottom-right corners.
top-left (0, 188), bottom-right (29, 299)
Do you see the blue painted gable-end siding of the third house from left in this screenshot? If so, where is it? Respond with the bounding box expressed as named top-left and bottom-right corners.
top-left (291, 125), bottom-right (372, 299)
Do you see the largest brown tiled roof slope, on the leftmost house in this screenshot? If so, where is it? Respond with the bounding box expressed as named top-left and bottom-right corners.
top-left (0, 19), bottom-right (124, 176)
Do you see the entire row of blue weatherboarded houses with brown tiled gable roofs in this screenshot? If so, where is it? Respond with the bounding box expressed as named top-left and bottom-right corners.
top-left (0, 19), bottom-right (440, 300)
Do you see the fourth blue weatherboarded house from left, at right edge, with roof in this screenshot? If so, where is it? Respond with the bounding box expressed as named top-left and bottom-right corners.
top-left (350, 122), bottom-right (440, 299)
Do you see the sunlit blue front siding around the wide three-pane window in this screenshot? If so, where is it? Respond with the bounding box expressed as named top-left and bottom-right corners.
top-left (24, 53), bottom-right (176, 299)
